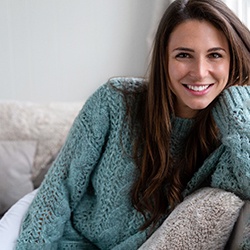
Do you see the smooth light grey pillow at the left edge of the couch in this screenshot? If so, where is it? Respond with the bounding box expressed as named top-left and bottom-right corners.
top-left (0, 141), bottom-right (36, 215)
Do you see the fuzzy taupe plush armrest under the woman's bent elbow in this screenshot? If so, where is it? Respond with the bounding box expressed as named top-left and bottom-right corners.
top-left (139, 188), bottom-right (244, 250)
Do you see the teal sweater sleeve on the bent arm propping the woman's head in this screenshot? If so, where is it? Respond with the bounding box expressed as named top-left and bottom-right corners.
top-left (211, 86), bottom-right (250, 199)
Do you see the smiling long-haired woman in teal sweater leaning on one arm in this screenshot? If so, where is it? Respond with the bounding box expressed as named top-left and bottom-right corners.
top-left (17, 0), bottom-right (250, 250)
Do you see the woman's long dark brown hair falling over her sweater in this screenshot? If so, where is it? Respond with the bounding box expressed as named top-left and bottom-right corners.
top-left (132, 0), bottom-right (250, 229)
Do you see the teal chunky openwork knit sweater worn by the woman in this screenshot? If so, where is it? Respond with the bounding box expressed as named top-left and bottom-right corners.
top-left (16, 78), bottom-right (250, 250)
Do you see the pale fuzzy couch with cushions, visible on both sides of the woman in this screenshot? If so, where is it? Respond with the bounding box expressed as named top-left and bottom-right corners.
top-left (0, 102), bottom-right (250, 250)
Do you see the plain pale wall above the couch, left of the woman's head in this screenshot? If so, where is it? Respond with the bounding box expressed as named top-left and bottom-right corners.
top-left (0, 0), bottom-right (154, 102)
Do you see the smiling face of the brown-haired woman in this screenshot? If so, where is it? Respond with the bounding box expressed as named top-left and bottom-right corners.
top-left (167, 20), bottom-right (230, 118)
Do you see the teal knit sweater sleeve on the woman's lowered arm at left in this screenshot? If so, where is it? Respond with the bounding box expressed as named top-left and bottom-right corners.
top-left (16, 85), bottom-right (109, 250)
